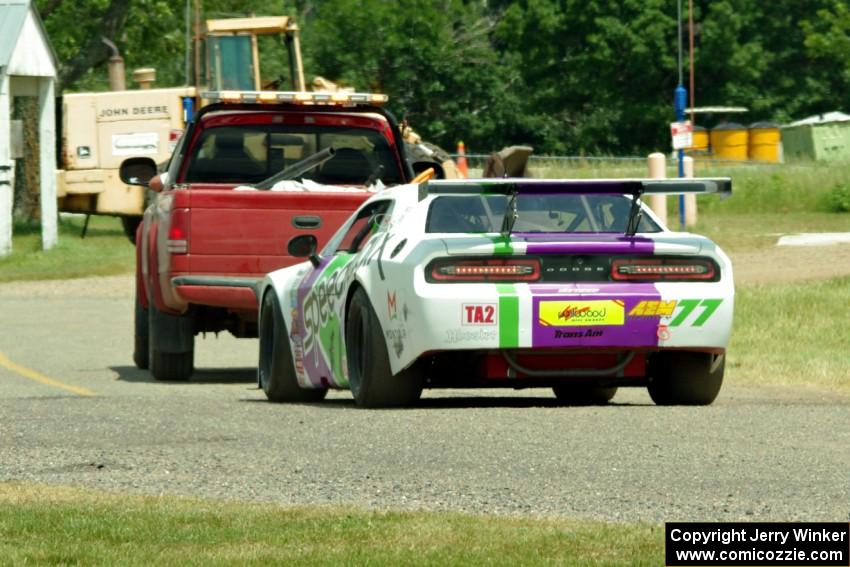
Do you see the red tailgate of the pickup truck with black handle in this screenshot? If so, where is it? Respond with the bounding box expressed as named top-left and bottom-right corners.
top-left (182, 188), bottom-right (371, 276)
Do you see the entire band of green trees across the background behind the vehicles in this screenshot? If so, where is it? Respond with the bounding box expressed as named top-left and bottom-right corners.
top-left (36, 0), bottom-right (850, 155)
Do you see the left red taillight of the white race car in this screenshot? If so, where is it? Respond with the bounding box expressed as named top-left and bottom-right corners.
top-left (426, 258), bottom-right (540, 282)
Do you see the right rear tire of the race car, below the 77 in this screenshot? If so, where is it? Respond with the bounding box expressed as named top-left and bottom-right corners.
top-left (647, 352), bottom-right (726, 406)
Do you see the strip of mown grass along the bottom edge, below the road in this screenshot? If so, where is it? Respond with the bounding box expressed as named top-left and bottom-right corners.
top-left (0, 483), bottom-right (663, 566)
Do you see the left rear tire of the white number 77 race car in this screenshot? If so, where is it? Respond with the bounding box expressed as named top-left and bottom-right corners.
top-left (345, 288), bottom-right (422, 408)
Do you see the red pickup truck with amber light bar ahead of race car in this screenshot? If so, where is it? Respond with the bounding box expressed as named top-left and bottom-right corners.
top-left (121, 93), bottom-right (419, 380)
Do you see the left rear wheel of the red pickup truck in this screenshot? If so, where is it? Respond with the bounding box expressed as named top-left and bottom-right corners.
top-left (148, 302), bottom-right (195, 381)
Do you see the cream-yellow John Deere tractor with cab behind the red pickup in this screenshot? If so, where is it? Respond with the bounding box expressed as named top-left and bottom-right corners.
top-left (57, 16), bottom-right (305, 240)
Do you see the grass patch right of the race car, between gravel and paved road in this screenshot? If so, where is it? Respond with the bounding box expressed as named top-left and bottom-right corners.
top-left (726, 278), bottom-right (850, 394)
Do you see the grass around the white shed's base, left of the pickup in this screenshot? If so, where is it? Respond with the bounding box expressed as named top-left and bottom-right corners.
top-left (0, 216), bottom-right (136, 282)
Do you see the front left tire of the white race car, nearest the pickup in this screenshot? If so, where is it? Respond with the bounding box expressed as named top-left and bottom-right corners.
top-left (257, 292), bottom-right (328, 403)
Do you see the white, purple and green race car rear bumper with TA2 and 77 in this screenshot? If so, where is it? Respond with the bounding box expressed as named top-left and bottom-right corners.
top-left (384, 281), bottom-right (734, 371)
